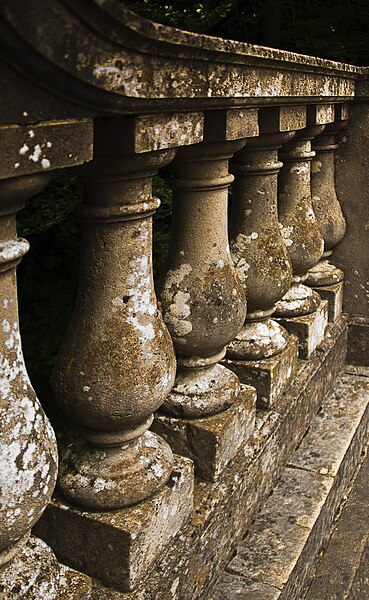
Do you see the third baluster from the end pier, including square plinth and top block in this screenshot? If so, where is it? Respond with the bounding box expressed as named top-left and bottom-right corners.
top-left (221, 107), bottom-right (306, 406)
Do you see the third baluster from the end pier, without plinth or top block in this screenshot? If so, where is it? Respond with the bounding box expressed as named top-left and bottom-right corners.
top-left (227, 132), bottom-right (294, 360)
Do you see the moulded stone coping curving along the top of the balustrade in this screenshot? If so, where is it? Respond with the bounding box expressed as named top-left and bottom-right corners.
top-left (0, 0), bottom-right (368, 122)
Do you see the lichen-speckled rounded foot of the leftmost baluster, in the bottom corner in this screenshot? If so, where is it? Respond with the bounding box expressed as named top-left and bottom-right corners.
top-left (0, 536), bottom-right (60, 600)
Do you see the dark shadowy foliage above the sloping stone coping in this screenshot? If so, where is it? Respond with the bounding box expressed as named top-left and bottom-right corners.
top-left (125, 0), bottom-right (369, 65)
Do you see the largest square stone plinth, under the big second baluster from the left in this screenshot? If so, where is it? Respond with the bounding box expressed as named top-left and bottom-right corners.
top-left (35, 456), bottom-right (194, 592)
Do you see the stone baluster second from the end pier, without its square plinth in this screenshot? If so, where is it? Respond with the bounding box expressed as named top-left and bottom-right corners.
top-left (275, 125), bottom-right (324, 317)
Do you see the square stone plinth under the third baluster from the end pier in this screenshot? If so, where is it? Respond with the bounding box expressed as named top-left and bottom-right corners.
top-left (222, 335), bottom-right (298, 408)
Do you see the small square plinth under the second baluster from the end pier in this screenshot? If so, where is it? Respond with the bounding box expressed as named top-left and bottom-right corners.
top-left (276, 300), bottom-right (328, 359)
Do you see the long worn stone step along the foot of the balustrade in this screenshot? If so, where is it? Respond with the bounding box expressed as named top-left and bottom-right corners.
top-left (208, 368), bottom-right (369, 600)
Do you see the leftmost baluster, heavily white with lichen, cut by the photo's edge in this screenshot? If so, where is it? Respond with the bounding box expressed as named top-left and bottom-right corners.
top-left (0, 174), bottom-right (59, 599)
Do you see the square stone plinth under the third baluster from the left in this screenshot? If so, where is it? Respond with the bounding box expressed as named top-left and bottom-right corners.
top-left (151, 386), bottom-right (256, 481)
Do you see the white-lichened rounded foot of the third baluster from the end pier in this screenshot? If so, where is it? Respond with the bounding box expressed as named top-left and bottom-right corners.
top-left (227, 319), bottom-right (288, 361)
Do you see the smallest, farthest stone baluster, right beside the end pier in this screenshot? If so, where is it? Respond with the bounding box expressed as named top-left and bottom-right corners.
top-left (306, 105), bottom-right (349, 288)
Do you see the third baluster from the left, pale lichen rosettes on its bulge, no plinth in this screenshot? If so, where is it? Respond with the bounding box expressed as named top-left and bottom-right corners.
top-left (160, 140), bottom-right (246, 418)
